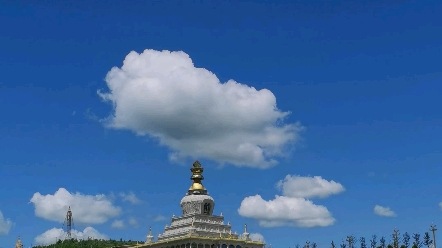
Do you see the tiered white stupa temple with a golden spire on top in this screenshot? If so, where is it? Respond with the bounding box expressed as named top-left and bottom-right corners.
top-left (137, 160), bottom-right (265, 248)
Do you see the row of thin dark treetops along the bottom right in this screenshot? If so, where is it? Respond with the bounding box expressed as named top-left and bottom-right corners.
top-left (295, 230), bottom-right (436, 248)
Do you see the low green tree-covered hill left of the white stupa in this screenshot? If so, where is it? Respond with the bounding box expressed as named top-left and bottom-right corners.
top-left (33, 239), bottom-right (144, 248)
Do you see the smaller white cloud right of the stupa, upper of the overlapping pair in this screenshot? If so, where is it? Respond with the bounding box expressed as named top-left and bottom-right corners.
top-left (277, 175), bottom-right (345, 198)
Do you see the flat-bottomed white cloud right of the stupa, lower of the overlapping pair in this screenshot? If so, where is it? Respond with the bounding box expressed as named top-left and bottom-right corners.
top-left (238, 195), bottom-right (335, 227)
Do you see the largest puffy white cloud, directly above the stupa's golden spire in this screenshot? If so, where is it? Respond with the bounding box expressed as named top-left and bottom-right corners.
top-left (98, 50), bottom-right (302, 168)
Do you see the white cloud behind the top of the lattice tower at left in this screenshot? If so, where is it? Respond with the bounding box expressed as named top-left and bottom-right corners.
top-left (31, 188), bottom-right (121, 224)
